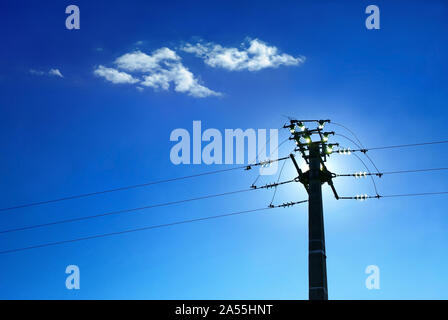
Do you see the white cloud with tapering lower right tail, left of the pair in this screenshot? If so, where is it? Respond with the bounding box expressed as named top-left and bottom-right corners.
top-left (95, 48), bottom-right (221, 98)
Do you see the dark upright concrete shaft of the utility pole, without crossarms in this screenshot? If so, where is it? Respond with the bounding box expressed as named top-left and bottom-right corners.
top-left (308, 143), bottom-right (328, 300)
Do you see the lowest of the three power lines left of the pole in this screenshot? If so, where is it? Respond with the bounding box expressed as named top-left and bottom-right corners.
top-left (0, 200), bottom-right (307, 254)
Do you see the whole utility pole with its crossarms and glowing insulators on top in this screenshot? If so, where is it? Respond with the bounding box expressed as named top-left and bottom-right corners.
top-left (284, 120), bottom-right (339, 300)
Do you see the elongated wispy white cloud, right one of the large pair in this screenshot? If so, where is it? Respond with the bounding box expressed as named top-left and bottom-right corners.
top-left (181, 39), bottom-right (305, 71)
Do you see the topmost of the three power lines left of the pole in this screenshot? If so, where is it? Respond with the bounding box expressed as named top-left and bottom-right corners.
top-left (0, 157), bottom-right (289, 212)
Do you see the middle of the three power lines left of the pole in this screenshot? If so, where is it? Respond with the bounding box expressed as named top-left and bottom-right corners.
top-left (0, 180), bottom-right (295, 234)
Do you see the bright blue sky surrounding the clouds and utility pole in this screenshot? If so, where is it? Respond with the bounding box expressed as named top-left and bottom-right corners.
top-left (0, 1), bottom-right (448, 299)
